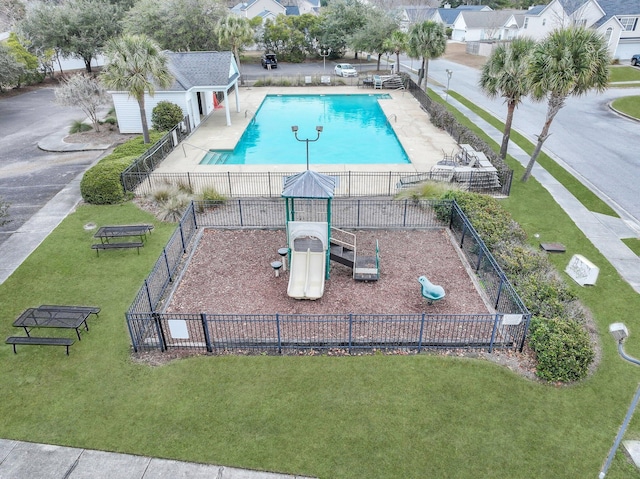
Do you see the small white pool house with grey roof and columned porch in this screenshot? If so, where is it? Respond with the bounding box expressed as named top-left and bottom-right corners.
top-left (109, 52), bottom-right (240, 133)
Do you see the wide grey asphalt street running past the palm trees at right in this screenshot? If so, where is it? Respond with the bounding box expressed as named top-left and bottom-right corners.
top-left (422, 55), bottom-right (640, 225)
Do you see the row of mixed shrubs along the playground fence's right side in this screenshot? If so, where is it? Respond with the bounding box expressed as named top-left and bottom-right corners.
top-left (443, 191), bottom-right (595, 382)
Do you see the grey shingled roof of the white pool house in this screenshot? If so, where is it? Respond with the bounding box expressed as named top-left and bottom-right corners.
top-left (165, 52), bottom-right (238, 91)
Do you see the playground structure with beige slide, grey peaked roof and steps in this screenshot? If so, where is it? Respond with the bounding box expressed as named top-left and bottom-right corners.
top-left (282, 170), bottom-right (379, 300)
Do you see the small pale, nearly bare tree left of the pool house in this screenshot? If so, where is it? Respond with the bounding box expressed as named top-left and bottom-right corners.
top-left (55, 74), bottom-right (109, 131)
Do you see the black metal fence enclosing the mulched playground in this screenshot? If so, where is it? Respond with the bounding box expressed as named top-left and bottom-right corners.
top-left (126, 199), bottom-right (530, 354)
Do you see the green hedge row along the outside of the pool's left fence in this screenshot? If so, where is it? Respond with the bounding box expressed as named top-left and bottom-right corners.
top-left (80, 131), bottom-right (163, 205)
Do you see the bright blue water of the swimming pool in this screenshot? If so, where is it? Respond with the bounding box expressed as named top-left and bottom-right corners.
top-left (200, 95), bottom-right (410, 166)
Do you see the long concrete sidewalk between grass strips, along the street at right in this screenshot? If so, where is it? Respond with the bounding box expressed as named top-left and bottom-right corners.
top-left (434, 90), bottom-right (640, 293)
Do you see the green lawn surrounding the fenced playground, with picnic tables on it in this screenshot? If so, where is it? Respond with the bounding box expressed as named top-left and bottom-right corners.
top-left (0, 120), bottom-right (640, 479)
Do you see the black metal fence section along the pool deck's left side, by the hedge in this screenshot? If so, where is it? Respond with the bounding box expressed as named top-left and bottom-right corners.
top-left (120, 115), bottom-right (191, 191)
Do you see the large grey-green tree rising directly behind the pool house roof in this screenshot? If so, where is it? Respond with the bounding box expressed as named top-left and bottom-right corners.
top-left (123, 0), bottom-right (227, 52)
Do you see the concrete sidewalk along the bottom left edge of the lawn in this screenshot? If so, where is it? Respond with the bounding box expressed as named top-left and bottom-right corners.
top-left (0, 439), bottom-right (309, 479)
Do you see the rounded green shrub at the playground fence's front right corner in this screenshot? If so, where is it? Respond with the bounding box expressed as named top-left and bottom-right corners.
top-left (529, 317), bottom-right (595, 382)
